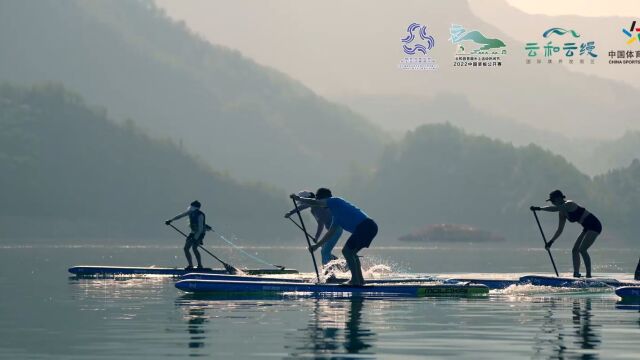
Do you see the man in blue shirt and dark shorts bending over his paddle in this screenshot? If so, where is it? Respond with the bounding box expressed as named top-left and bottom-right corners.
top-left (291, 188), bottom-right (378, 286)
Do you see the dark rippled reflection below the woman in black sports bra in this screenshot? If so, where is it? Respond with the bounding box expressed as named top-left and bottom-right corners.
top-left (533, 298), bottom-right (602, 360)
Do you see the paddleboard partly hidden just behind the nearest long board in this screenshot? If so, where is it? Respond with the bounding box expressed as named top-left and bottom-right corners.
top-left (181, 273), bottom-right (440, 284)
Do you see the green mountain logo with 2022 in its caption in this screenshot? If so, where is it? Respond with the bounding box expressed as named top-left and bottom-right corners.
top-left (449, 24), bottom-right (507, 67)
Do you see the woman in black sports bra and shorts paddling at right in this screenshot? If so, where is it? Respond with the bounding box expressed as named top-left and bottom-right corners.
top-left (531, 190), bottom-right (602, 278)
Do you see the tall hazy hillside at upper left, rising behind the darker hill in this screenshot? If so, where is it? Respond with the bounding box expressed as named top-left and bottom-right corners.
top-left (0, 0), bottom-right (382, 188)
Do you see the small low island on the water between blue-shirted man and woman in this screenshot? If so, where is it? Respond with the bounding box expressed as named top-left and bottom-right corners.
top-left (399, 224), bottom-right (505, 243)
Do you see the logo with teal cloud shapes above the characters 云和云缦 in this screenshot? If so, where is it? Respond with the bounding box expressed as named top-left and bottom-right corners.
top-left (524, 27), bottom-right (598, 64)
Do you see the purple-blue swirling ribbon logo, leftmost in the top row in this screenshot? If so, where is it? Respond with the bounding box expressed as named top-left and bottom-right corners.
top-left (398, 23), bottom-right (438, 70)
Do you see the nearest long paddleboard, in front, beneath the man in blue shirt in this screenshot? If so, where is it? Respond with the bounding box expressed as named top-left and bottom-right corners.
top-left (176, 280), bottom-right (489, 297)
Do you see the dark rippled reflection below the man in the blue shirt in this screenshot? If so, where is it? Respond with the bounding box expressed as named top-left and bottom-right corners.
top-left (285, 297), bottom-right (375, 359)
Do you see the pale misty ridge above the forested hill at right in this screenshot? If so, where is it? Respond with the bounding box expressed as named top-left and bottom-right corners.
top-left (344, 93), bottom-right (640, 176)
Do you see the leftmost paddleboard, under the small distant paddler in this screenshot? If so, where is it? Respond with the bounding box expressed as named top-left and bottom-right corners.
top-left (69, 266), bottom-right (298, 276)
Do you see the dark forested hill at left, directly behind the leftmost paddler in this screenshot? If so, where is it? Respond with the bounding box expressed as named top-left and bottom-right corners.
top-left (0, 84), bottom-right (297, 241)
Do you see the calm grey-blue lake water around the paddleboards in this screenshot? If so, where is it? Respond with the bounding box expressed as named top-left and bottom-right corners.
top-left (0, 242), bottom-right (640, 359)
